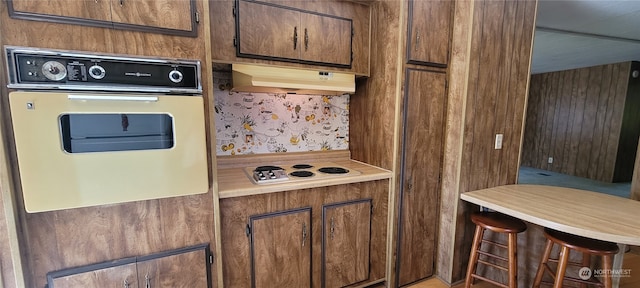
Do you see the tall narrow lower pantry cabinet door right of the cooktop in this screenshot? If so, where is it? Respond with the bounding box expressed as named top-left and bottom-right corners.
top-left (396, 69), bottom-right (446, 286)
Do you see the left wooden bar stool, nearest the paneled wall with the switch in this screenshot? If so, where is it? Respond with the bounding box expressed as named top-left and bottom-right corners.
top-left (464, 212), bottom-right (527, 288)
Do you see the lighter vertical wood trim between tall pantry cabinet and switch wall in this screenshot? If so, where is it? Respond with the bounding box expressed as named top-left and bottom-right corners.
top-left (436, 1), bottom-right (475, 284)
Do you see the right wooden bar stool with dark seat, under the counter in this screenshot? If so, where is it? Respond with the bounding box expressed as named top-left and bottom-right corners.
top-left (533, 228), bottom-right (618, 288)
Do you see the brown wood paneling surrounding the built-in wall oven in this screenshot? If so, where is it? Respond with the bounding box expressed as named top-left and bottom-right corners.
top-left (0, 0), bottom-right (216, 287)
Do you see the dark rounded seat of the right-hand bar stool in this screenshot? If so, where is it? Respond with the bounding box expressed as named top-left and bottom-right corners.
top-left (544, 228), bottom-right (619, 255)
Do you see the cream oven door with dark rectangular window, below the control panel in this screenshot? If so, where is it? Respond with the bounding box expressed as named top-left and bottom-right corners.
top-left (9, 92), bottom-right (209, 212)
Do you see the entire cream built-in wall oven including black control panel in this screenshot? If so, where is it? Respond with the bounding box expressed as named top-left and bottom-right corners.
top-left (5, 46), bottom-right (209, 212)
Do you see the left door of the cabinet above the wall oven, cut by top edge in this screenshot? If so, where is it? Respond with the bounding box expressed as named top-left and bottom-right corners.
top-left (9, 0), bottom-right (111, 21)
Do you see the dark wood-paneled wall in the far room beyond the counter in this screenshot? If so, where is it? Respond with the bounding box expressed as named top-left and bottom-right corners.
top-left (522, 62), bottom-right (638, 182)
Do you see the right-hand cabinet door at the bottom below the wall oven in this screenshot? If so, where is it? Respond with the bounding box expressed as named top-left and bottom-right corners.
top-left (138, 248), bottom-right (210, 288)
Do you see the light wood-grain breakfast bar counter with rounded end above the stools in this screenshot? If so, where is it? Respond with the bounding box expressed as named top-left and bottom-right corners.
top-left (460, 184), bottom-right (640, 287)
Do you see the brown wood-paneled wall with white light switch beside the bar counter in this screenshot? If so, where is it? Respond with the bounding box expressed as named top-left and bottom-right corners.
top-left (448, 0), bottom-right (537, 287)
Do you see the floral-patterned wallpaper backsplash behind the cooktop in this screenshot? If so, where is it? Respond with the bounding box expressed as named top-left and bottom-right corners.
top-left (214, 73), bottom-right (349, 155)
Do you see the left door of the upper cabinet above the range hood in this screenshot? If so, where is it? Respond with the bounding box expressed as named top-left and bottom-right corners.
top-left (236, 1), bottom-right (302, 59)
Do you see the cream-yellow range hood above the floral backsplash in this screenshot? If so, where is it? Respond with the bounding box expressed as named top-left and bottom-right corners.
top-left (231, 64), bottom-right (356, 95)
